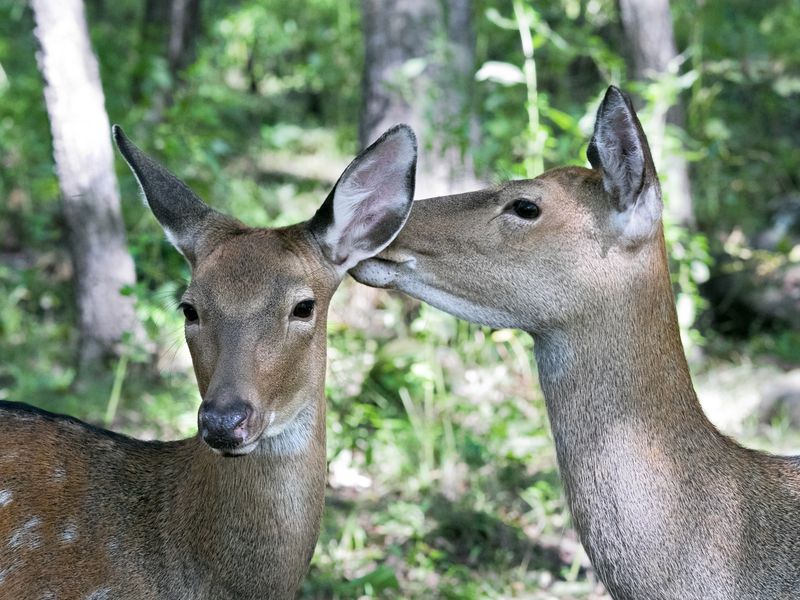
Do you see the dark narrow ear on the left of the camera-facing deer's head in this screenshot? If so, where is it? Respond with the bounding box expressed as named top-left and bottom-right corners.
top-left (111, 125), bottom-right (242, 266)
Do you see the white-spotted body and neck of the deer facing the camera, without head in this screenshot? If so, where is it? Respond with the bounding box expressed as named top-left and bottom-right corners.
top-left (0, 402), bottom-right (326, 600)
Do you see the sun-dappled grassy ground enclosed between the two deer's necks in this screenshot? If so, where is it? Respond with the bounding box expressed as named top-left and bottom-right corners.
top-left (304, 283), bottom-right (596, 598)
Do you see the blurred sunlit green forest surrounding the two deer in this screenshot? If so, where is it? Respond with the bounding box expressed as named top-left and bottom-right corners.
top-left (0, 0), bottom-right (800, 599)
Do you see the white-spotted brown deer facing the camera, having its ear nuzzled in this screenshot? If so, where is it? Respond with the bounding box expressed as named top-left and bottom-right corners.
top-left (0, 125), bottom-right (417, 600)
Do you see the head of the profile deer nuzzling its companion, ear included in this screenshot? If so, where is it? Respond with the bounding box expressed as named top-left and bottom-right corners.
top-left (351, 87), bottom-right (663, 334)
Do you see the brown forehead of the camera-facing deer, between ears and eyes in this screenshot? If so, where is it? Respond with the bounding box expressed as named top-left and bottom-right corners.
top-left (187, 228), bottom-right (336, 317)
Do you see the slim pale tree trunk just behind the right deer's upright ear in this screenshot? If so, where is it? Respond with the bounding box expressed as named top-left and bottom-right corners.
top-left (619, 0), bottom-right (694, 228)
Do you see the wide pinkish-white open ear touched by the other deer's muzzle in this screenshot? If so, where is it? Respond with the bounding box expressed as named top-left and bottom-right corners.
top-left (308, 125), bottom-right (417, 274)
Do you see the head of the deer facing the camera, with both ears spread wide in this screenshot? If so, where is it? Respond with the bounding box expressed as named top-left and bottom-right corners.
top-left (113, 126), bottom-right (416, 455)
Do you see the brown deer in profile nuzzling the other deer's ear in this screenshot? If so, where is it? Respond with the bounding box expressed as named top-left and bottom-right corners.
top-left (352, 87), bottom-right (800, 600)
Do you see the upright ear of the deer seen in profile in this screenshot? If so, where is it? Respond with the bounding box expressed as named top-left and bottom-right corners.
top-left (586, 86), bottom-right (662, 245)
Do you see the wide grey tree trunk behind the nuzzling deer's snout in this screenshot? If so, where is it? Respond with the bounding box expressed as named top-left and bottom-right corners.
top-left (360, 0), bottom-right (480, 197)
